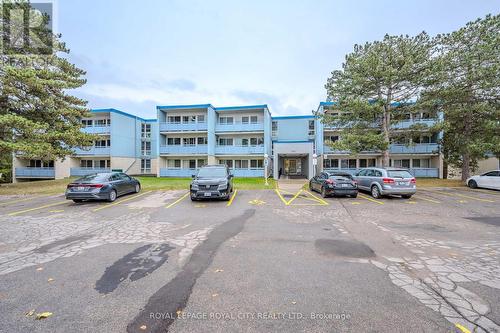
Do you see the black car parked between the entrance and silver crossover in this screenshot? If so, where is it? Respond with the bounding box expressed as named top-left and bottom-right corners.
top-left (309, 172), bottom-right (358, 198)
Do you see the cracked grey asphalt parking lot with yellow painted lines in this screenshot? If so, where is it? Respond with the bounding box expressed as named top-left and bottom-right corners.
top-left (0, 186), bottom-right (500, 332)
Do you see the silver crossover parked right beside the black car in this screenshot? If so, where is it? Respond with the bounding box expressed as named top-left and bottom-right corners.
top-left (354, 168), bottom-right (417, 199)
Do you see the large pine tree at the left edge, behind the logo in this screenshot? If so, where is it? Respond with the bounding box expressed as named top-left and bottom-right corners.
top-left (0, 1), bottom-right (95, 164)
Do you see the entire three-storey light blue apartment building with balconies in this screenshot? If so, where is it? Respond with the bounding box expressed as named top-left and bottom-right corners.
top-left (13, 102), bottom-right (450, 181)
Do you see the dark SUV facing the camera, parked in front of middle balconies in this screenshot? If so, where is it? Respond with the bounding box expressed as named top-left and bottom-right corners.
top-left (189, 165), bottom-right (233, 201)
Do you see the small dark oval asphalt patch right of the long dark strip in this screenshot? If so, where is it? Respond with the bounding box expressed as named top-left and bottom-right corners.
top-left (314, 239), bottom-right (375, 258)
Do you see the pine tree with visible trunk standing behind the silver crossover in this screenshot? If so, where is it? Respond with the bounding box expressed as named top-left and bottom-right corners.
top-left (319, 32), bottom-right (438, 166)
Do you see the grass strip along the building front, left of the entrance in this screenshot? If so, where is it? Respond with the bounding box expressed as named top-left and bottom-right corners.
top-left (0, 177), bottom-right (276, 195)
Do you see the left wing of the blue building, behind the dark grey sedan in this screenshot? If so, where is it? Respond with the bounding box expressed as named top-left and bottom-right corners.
top-left (13, 109), bottom-right (158, 181)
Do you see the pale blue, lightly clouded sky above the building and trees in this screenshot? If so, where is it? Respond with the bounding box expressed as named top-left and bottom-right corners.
top-left (55, 0), bottom-right (500, 118)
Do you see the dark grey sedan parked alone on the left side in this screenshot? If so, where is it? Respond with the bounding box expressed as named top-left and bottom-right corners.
top-left (66, 172), bottom-right (141, 202)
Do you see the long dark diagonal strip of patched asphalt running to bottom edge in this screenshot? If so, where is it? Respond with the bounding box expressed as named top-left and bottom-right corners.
top-left (127, 209), bottom-right (255, 332)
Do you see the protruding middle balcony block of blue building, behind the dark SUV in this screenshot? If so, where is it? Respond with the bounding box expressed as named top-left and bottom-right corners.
top-left (157, 104), bottom-right (272, 177)
